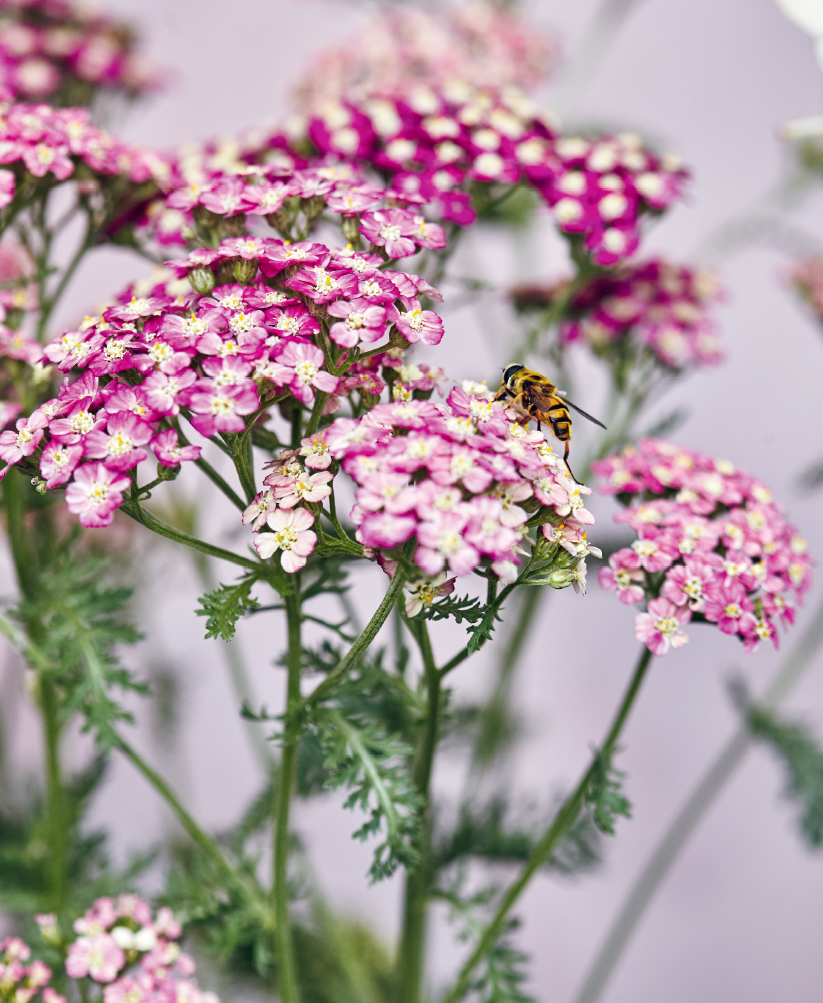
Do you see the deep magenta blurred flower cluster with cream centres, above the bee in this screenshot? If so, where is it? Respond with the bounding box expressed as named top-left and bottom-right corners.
top-left (281, 91), bottom-right (687, 254)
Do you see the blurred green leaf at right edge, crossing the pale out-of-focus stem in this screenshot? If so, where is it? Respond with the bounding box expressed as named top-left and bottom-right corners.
top-left (744, 704), bottom-right (823, 848)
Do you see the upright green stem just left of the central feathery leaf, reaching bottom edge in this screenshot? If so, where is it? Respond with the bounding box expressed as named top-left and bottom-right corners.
top-left (272, 590), bottom-right (303, 1003)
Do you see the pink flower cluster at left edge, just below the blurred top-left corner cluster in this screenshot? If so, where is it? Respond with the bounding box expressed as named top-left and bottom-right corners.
top-left (0, 102), bottom-right (168, 209)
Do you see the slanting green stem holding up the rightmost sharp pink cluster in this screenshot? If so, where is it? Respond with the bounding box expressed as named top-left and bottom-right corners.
top-left (443, 647), bottom-right (652, 1003)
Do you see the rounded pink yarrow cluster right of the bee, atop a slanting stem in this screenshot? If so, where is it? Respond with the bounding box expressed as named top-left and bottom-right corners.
top-left (592, 439), bottom-right (811, 655)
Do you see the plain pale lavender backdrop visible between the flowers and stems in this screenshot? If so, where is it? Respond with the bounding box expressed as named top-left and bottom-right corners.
top-left (0, 0), bottom-right (823, 1003)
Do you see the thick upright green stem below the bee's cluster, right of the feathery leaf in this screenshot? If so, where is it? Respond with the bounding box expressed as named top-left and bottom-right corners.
top-left (398, 620), bottom-right (441, 1003)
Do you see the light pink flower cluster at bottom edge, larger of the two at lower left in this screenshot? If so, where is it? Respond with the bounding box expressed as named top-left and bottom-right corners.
top-left (57, 895), bottom-right (219, 1003)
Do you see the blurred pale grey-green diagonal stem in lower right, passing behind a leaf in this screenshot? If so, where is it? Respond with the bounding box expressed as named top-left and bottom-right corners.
top-left (576, 604), bottom-right (823, 1003)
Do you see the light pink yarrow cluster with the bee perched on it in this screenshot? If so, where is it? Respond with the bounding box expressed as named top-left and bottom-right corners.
top-left (314, 384), bottom-right (593, 590)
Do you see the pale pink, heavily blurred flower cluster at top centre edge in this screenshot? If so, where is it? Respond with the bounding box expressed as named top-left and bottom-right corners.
top-left (296, 2), bottom-right (556, 114)
